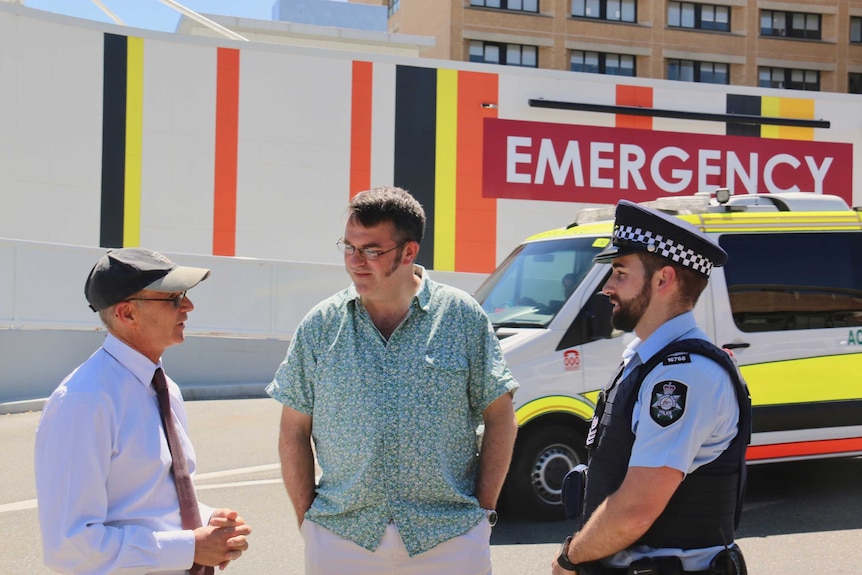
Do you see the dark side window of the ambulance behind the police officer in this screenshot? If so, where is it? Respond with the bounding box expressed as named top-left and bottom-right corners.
top-left (719, 232), bottom-right (862, 332)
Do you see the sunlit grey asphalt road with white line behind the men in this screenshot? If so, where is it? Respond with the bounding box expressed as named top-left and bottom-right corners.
top-left (0, 399), bottom-right (862, 575)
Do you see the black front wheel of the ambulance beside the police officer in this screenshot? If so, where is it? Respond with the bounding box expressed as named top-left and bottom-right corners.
top-left (503, 423), bottom-right (586, 521)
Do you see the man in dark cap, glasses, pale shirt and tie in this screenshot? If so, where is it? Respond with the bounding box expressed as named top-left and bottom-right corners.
top-left (36, 248), bottom-right (251, 574)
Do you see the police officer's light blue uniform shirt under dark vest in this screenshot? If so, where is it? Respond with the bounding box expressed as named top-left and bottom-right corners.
top-left (608, 312), bottom-right (739, 570)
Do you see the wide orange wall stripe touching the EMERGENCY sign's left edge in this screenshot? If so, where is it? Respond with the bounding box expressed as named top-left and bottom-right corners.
top-left (455, 72), bottom-right (499, 273)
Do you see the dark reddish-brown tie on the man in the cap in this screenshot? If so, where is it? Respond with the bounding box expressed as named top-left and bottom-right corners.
top-left (153, 368), bottom-right (214, 575)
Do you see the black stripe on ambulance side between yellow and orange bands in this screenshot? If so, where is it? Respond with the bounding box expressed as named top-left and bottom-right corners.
top-left (751, 399), bottom-right (862, 433)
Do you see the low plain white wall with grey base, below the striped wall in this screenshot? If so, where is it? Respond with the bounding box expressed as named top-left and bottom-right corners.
top-left (0, 239), bottom-right (485, 413)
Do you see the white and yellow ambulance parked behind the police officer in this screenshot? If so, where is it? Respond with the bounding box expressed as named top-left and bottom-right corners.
top-left (475, 194), bottom-right (862, 519)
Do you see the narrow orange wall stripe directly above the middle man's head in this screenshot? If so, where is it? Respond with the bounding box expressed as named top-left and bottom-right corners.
top-left (350, 61), bottom-right (374, 198)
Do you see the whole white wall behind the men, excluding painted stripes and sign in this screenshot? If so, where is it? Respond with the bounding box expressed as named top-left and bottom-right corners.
top-left (0, 2), bottom-right (862, 410)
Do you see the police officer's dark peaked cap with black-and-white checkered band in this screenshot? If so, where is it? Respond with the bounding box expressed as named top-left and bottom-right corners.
top-left (593, 200), bottom-right (727, 277)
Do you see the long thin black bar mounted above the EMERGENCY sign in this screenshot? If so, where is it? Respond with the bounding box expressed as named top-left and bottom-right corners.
top-left (527, 98), bottom-right (830, 128)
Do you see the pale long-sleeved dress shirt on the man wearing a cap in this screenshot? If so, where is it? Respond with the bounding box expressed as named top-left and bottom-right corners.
top-left (36, 335), bottom-right (212, 575)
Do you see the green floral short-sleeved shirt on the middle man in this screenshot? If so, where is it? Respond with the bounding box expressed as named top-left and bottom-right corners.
top-left (266, 266), bottom-right (518, 556)
